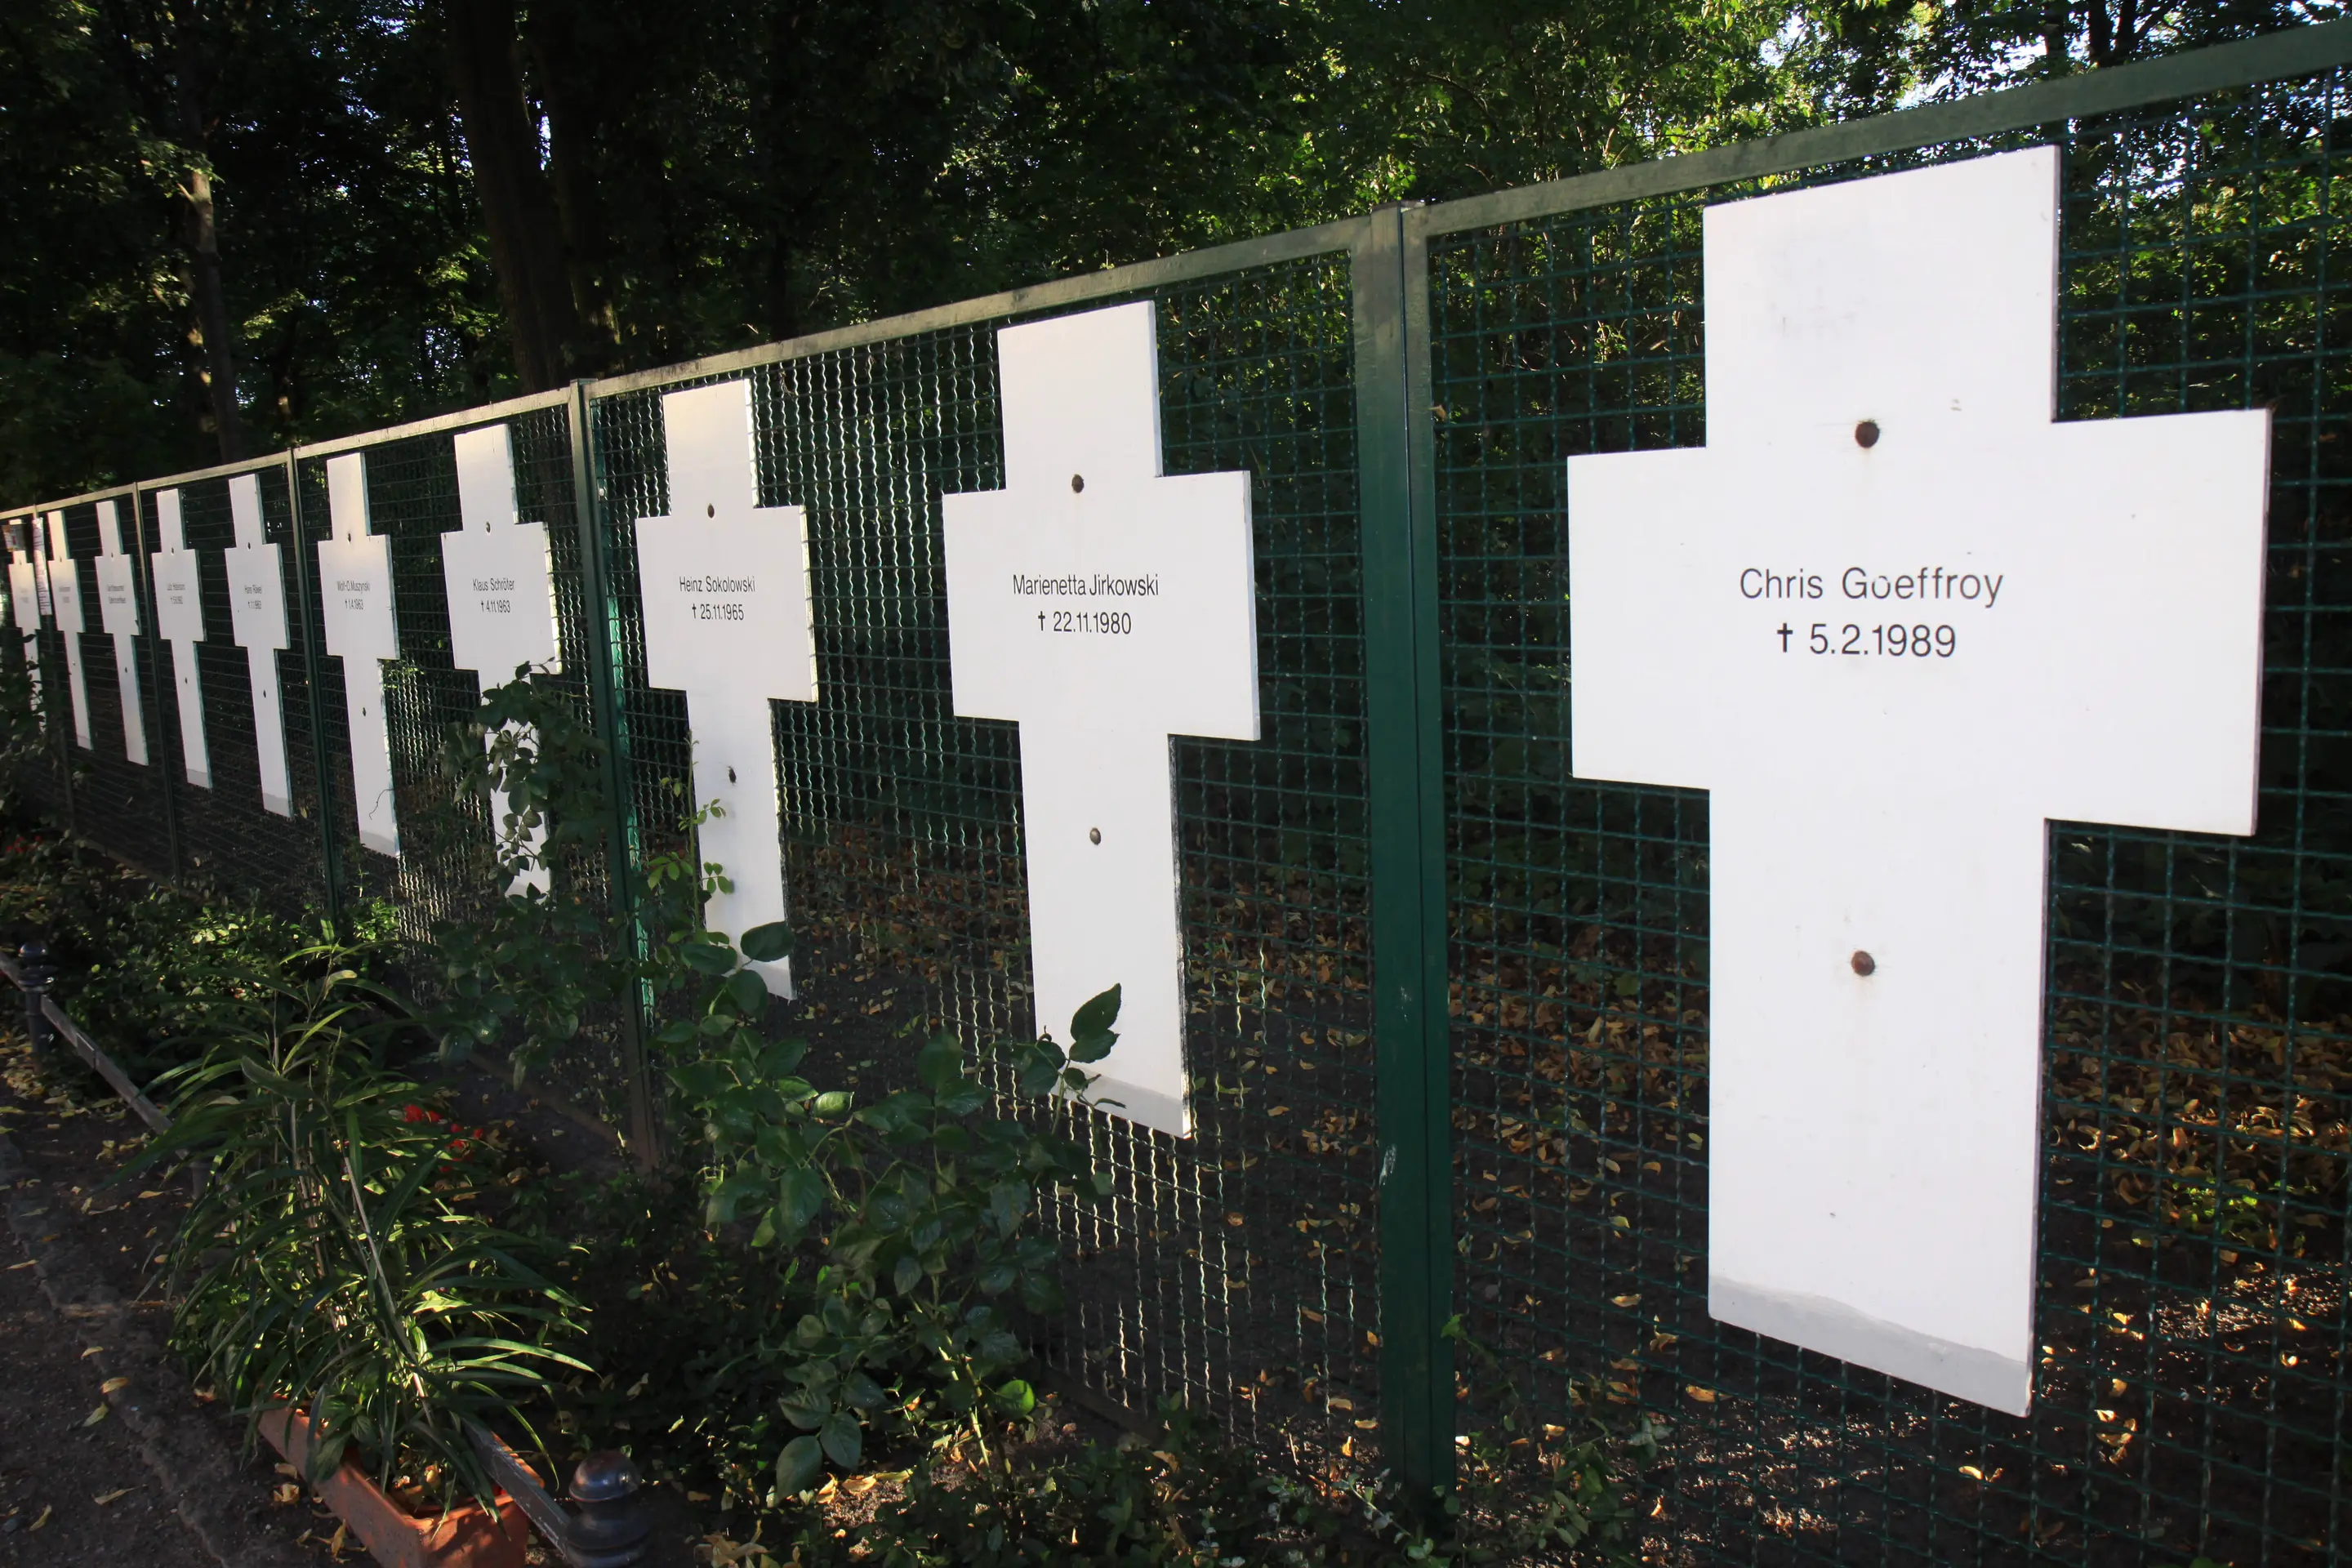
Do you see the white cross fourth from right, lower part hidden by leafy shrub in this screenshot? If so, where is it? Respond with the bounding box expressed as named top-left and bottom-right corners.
top-left (442, 425), bottom-right (558, 893)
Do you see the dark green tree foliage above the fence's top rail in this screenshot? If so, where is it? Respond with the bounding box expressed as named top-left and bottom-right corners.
top-left (0, 0), bottom-right (2342, 501)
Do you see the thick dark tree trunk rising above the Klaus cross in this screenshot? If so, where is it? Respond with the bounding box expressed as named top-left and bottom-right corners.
top-left (442, 0), bottom-right (581, 393)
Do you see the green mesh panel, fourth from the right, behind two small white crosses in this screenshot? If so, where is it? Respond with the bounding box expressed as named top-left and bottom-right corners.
top-left (141, 466), bottom-right (327, 917)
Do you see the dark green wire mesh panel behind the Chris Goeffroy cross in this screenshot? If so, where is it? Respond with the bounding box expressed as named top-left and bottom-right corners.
top-left (1430, 75), bottom-right (2352, 1563)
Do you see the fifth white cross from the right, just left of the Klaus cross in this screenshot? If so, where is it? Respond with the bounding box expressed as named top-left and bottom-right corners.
top-left (318, 452), bottom-right (400, 858)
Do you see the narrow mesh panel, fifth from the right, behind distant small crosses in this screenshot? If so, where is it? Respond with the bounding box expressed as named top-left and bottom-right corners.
top-left (51, 496), bottom-right (172, 877)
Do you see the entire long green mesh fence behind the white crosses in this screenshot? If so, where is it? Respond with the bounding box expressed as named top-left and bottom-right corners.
top-left (0, 24), bottom-right (2352, 1568)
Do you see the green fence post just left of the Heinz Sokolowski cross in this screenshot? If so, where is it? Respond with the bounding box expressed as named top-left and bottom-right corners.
top-left (567, 381), bottom-right (661, 1169)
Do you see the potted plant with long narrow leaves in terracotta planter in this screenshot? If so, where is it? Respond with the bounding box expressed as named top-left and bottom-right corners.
top-left (146, 950), bottom-right (586, 1568)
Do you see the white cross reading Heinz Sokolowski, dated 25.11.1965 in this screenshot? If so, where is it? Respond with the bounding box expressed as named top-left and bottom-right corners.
top-left (637, 381), bottom-right (816, 997)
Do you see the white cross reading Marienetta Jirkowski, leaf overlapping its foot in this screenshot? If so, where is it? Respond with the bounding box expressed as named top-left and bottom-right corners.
top-left (941, 303), bottom-right (1258, 1138)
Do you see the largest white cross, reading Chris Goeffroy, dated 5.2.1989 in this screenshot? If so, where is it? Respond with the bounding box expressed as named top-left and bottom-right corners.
top-left (1569, 148), bottom-right (2270, 1413)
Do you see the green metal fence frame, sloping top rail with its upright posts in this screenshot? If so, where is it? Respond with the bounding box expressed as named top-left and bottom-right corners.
top-left (7, 21), bottom-right (2352, 1542)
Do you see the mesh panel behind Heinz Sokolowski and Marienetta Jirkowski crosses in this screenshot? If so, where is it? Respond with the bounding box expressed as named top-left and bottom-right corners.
top-left (595, 259), bottom-right (1376, 1446)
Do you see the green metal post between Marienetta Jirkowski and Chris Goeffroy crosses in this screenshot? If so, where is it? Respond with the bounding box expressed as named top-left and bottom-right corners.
top-left (1352, 207), bottom-right (1454, 1512)
